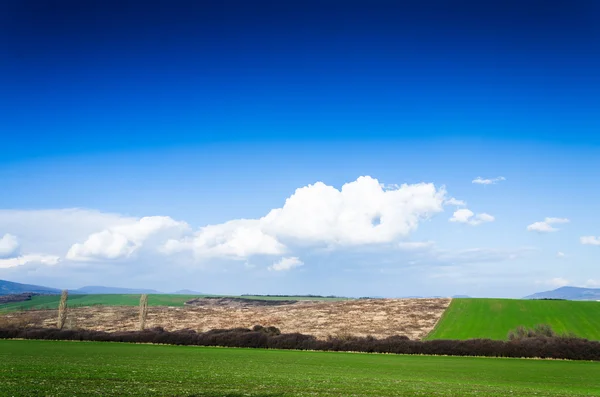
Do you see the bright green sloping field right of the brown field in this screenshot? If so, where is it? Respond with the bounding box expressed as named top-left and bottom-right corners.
top-left (427, 299), bottom-right (600, 340)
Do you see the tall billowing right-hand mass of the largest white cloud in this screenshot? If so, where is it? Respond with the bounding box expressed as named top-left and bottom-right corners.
top-left (261, 176), bottom-right (446, 245)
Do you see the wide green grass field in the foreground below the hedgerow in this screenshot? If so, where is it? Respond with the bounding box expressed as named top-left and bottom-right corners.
top-left (0, 340), bottom-right (600, 397)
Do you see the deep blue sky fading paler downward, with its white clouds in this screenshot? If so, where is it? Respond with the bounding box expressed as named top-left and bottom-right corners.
top-left (0, 1), bottom-right (600, 297)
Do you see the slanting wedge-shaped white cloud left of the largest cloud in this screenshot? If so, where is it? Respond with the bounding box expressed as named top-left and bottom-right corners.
top-left (66, 216), bottom-right (189, 261)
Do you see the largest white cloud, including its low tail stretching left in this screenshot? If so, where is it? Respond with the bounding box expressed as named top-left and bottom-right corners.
top-left (163, 176), bottom-right (446, 258)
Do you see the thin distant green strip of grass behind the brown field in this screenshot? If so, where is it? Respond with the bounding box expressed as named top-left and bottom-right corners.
top-left (0, 294), bottom-right (343, 312)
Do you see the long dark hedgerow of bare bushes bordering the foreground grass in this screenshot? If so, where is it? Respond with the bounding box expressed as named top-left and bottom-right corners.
top-left (0, 326), bottom-right (600, 361)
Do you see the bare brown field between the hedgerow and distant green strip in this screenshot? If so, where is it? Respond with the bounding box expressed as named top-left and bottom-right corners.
top-left (0, 299), bottom-right (450, 339)
